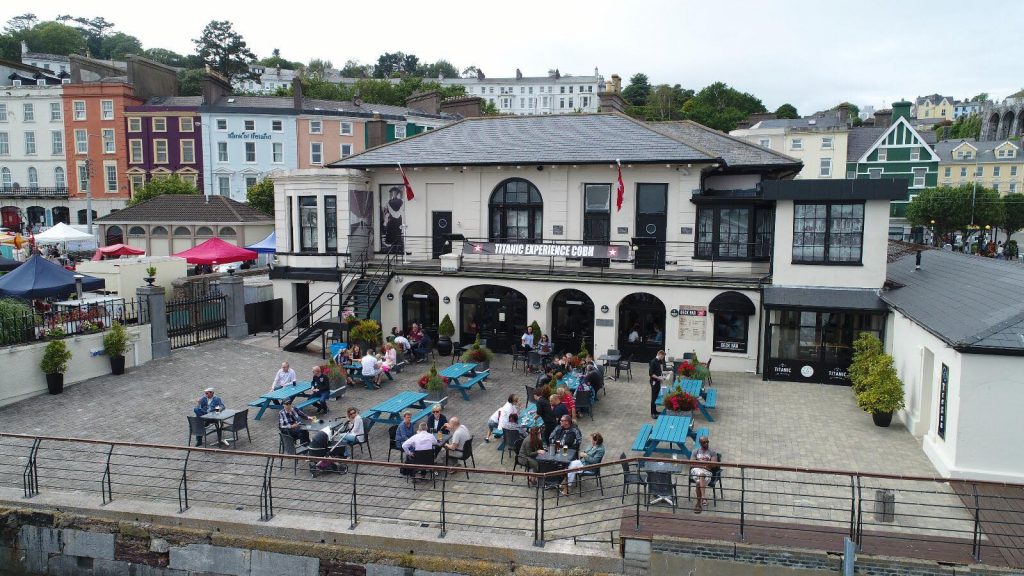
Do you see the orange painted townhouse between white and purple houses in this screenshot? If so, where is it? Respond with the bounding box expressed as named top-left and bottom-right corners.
top-left (63, 82), bottom-right (144, 224)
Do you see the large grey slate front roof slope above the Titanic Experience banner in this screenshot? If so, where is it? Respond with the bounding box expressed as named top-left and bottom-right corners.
top-left (330, 114), bottom-right (721, 168)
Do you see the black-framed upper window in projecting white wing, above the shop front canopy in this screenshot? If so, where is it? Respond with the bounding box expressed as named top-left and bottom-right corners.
top-left (793, 203), bottom-right (864, 264)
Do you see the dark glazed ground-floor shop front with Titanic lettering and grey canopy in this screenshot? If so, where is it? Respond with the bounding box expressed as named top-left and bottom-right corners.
top-left (763, 287), bottom-right (888, 385)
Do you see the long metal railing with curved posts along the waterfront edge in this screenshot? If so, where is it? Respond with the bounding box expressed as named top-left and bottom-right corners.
top-left (0, 429), bottom-right (1024, 568)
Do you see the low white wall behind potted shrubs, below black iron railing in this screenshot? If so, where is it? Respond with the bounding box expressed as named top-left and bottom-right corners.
top-left (0, 324), bottom-right (153, 406)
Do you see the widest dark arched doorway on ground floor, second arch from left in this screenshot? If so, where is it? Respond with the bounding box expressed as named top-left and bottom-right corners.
top-left (459, 284), bottom-right (526, 354)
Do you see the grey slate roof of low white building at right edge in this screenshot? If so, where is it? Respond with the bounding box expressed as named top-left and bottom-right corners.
top-left (882, 250), bottom-right (1024, 356)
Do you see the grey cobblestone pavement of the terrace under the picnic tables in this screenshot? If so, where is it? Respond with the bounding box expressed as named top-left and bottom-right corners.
top-left (0, 336), bottom-right (966, 537)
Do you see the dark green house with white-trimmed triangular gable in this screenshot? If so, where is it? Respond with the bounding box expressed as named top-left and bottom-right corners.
top-left (846, 101), bottom-right (939, 240)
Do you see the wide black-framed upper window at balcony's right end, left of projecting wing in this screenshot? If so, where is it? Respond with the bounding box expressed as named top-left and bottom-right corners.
top-left (695, 205), bottom-right (775, 260)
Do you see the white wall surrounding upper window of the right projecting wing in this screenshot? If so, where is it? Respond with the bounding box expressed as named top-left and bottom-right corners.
top-left (772, 200), bottom-right (889, 288)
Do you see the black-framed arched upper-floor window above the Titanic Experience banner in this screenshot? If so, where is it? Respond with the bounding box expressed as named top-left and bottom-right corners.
top-left (489, 178), bottom-right (544, 242)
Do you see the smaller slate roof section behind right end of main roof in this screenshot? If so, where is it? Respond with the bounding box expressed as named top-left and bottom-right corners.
top-left (649, 120), bottom-right (801, 168)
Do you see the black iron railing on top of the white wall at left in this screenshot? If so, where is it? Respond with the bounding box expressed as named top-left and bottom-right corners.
top-left (0, 297), bottom-right (140, 345)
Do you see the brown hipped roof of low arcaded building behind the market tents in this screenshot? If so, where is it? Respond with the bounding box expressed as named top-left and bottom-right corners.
top-left (96, 194), bottom-right (273, 224)
